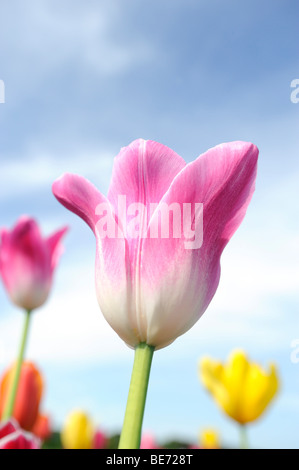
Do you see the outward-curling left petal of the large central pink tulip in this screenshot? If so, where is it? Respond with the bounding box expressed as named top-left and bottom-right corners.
top-left (52, 174), bottom-right (136, 344)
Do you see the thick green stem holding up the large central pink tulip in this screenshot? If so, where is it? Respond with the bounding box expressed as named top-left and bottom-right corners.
top-left (118, 343), bottom-right (155, 449)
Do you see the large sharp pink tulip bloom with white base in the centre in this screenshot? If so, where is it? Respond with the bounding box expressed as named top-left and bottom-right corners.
top-left (53, 139), bottom-right (258, 349)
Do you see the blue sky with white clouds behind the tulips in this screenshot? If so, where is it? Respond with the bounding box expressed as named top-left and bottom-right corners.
top-left (0, 0), bottom-right (299, 448)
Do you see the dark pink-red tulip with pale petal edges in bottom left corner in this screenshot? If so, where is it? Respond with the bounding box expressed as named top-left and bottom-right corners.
top-left (0, 418), bottom-right (40, 449)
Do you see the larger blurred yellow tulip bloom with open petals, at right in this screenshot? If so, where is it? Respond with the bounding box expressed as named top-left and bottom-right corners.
top-left (199, 350), bottom-right (279, 425)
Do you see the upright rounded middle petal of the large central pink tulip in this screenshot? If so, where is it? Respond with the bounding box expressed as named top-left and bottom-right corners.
top-left (108, 139), bottom-right (186, 252)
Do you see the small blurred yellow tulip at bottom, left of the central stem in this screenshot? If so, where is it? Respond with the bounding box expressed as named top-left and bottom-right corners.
top-left (60, 410), bottom-right (95, 449)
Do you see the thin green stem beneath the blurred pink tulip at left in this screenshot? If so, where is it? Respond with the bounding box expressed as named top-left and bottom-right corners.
top-left (2, 310), bottom-right (30, 420)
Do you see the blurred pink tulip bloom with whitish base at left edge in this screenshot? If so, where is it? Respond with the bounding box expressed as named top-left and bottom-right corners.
top-left (0, 216), bottom-right (67, 310)
